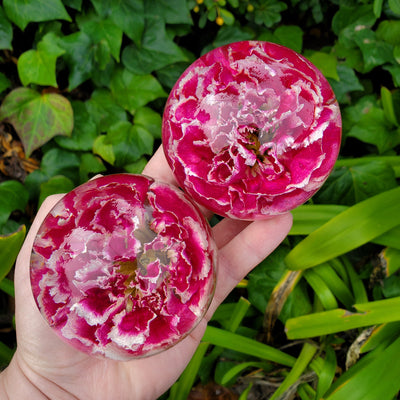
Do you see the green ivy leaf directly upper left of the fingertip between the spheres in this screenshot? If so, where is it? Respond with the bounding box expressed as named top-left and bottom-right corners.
top-left (104, 121), bottom-right (154, 167)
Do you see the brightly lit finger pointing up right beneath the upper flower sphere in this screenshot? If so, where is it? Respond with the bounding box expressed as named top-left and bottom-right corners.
top-left (207, 213), bottom-right (292, 319)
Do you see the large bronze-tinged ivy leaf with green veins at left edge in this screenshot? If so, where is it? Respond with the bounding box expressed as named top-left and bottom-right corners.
top-left (0, 88), bottom-right (73, 157)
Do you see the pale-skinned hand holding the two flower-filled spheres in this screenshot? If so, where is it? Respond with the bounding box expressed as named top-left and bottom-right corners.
top-left (0, 149), bottom-right (292, 400)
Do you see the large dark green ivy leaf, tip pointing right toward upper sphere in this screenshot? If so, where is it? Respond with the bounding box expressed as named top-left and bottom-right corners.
top-left (122, 18), bottom-right (188, 75)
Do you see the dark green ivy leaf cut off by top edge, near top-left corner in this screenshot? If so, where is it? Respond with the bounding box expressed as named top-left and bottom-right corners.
top-left (3, 0), bottom-right (71, 30)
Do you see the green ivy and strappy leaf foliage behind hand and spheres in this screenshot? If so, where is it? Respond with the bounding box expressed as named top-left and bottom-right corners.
top-left (0, 0), bottom-right (400, 400)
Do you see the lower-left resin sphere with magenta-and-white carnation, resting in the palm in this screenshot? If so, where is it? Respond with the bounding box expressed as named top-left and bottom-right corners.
top-left (31, 174), bottom-right (216, 360)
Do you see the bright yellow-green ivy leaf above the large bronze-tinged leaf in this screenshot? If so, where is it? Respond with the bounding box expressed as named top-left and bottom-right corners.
top-left (18, 33), bottom-right (65, 87)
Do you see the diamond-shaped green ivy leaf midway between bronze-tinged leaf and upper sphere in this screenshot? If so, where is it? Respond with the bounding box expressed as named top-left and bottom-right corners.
top-left (85, 89), bottom-right (128, 133)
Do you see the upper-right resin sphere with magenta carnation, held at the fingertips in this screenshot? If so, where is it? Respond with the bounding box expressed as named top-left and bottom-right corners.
top-left (163, 41), bottom-right (341, 220)
